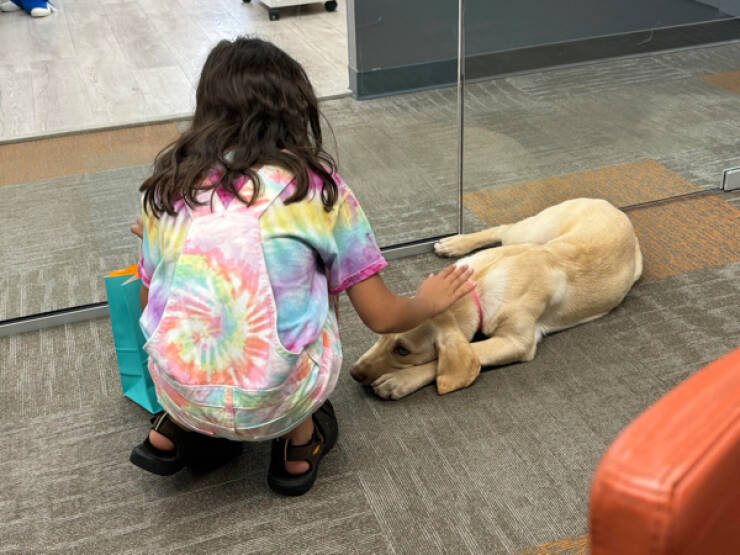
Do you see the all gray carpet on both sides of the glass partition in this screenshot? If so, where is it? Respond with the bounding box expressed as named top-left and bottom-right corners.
top-left (5, 44), bottom-right (740, 554)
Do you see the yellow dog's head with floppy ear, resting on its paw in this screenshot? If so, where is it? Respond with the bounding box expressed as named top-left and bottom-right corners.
top-left (350, 312), bottom-right (480, 394)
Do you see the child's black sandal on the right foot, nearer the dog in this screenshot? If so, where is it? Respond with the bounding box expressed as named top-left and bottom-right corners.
top-left (267, 401), bottom-right (339, 495)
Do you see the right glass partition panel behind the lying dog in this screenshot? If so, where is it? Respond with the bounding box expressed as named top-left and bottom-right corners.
top-left (464, 0), bottom-right (740, 226)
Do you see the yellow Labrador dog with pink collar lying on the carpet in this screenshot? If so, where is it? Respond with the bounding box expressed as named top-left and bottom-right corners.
top-left (350, 198), bottom-right (642, 399)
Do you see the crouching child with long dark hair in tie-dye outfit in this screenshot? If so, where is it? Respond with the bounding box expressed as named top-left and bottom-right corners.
top-left (131, 38), bottom-right (472, 495)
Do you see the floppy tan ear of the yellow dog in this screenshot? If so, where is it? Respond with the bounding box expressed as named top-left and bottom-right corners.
top-left (434, 313), bottom-right (480, 395)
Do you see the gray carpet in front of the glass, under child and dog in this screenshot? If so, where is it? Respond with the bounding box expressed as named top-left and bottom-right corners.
top-left (0, 255), bottom-right (740, 554)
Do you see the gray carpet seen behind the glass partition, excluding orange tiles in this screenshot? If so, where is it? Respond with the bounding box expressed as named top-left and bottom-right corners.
top-left (0, 43), bottom-right (740, 320)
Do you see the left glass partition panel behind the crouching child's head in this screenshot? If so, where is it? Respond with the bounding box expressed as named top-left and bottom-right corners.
top-left (0, 0), bottom-right (458, 321)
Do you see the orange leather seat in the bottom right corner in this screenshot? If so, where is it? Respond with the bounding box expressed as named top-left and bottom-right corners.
top-left (589, 348), bottom-right (740, 555)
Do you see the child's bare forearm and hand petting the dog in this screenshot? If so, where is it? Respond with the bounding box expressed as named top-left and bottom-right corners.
top-left (347, 265), bottom-right (475, 333)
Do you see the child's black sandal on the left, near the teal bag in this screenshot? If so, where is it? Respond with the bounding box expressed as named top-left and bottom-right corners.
top-left (129, 411), bottom-right (240, 476)
